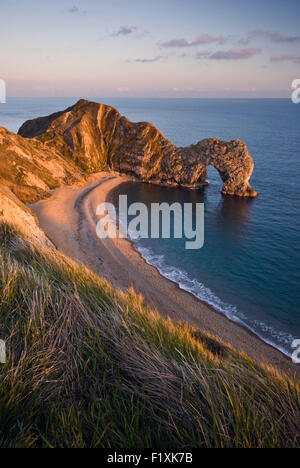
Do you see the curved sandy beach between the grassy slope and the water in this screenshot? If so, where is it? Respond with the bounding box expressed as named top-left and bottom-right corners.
top-left (30, 173), bottom-right (299, 375)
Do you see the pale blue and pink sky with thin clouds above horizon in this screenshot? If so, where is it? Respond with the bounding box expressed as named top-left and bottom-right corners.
top-left (0, 0), bottom-right (300, 98)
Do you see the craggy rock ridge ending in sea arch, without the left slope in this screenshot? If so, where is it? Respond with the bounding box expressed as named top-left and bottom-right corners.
top-left (15, 100), bottom-right (257, 197)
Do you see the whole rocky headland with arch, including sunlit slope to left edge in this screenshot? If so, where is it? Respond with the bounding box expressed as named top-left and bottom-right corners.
top-left (0, 100), bottom-right (257, 202)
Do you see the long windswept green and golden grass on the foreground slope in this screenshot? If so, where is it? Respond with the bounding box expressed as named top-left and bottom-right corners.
top-left (0, 224), bottom-right (300, 448)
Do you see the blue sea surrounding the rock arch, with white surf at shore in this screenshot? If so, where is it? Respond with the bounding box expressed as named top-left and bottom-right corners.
top-left (0, 98), bottom-right (300, 355)
